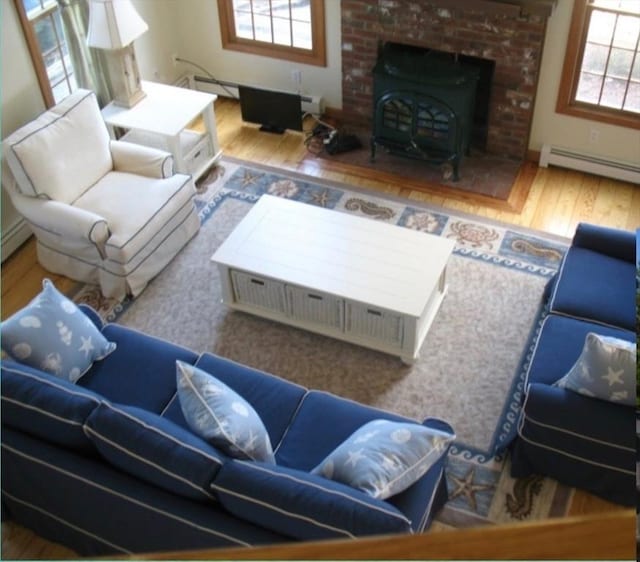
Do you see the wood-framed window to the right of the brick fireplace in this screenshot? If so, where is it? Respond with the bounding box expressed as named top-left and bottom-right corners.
top-left (556, 0), bottom-right (640, 129)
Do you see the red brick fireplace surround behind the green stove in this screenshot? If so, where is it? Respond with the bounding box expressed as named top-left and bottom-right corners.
top-left (341, 0), bottom-right (555, 160)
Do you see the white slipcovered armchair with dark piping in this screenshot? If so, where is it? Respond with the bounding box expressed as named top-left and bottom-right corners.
top-left (3, 90), bottom-right (200, 297)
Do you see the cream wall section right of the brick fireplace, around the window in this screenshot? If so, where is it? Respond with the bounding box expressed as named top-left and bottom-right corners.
top-left (529, 0), bottom-right (640, 164)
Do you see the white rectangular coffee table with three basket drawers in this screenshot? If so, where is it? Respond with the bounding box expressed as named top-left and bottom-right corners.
top-left (211, 195), bottom-right (454, 363)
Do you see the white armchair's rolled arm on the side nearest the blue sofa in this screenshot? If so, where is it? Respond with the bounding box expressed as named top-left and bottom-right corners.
top-left (11, 193), bottom-right (111, 258)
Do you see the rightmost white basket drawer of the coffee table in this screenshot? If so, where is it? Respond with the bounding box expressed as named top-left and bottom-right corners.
top-left (346, 302), bottom-right (404, 347)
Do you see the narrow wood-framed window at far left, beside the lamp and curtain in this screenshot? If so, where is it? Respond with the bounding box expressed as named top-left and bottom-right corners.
top-left (14, 0), bottom-right (77, 107)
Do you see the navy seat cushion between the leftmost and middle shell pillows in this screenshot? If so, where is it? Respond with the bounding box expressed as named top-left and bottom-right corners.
top-left (78, 324), bottom-right (198, 414)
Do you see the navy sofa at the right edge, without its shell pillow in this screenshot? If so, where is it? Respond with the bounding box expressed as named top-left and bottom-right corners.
top-left (511, 223), bottom-right (637, 506)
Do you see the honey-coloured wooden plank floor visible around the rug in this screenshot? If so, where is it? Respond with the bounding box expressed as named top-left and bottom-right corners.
top-left (1, 99), bottom-right (640, 559)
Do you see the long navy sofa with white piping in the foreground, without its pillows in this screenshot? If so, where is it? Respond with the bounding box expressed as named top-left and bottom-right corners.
top-left (2, 307), bottom-right (453, 556)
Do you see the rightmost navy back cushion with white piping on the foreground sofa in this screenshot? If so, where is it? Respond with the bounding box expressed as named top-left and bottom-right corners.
top-left (212, 460), bottom-right (411, 540)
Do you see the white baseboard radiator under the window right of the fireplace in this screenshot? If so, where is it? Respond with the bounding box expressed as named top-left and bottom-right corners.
top-left (540, 144), bottom-right (640, 184)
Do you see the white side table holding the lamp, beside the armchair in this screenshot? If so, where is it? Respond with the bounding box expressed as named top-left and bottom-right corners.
top-left (102, 80), bottom-right (222, 180)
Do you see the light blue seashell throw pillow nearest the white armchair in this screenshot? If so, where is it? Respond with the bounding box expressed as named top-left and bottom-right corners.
top-left (1, 279), bottom-right (116, 383)
